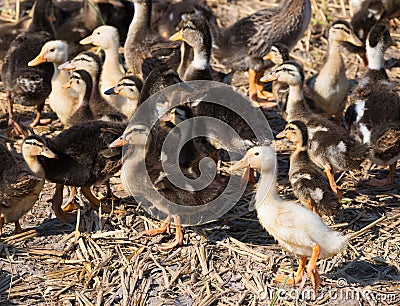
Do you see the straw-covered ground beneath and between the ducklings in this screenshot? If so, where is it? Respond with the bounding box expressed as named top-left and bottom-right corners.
top-left (0, 0), bottom-right (400, 306)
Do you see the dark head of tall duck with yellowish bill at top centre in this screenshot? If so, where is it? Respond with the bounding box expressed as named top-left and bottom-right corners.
top-left (170, 17), bottom-right (211, 50)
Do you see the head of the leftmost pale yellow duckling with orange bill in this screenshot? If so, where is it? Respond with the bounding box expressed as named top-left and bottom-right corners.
top-left (28, 40), bottom-right (68, 66)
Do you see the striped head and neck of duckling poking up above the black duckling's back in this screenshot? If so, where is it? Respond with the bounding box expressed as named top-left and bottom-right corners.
top-left (104, 75), bottom-right (143, 119)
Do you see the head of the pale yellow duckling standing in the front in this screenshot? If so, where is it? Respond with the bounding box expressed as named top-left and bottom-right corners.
top-left (230, 146), bottom-right (275, 172)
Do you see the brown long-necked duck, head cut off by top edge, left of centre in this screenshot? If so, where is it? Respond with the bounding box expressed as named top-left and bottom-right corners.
top-left (124, 0), bottom-right (180, 75)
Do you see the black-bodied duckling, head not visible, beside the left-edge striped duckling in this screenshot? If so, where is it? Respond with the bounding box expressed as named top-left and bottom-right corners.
top-left (27, 120), bottom-right (126, 222)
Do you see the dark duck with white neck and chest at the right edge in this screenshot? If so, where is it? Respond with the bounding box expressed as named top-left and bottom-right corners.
top-left (345, 24), bottom-right (400, 186)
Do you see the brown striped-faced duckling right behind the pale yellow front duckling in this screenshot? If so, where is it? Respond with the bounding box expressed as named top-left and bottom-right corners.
top-left (276, 120), bottom-right (340, 216)
